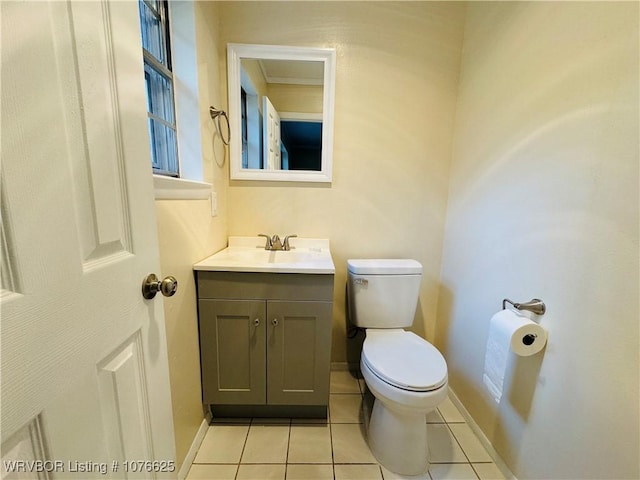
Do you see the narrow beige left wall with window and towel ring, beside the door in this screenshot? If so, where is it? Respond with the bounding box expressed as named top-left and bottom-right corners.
top-left (156, 2), bottom-right (229, 468)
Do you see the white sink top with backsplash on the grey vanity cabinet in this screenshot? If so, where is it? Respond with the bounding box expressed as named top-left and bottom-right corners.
top-left (193, 237), bottom-right (335, 274)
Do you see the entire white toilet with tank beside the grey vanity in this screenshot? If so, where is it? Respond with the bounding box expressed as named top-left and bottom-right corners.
top-left (347, 259), bottom-right (447, 475)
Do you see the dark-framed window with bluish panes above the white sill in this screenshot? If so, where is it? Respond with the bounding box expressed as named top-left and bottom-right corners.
top-left (138, 0), bottom-right (179, 177)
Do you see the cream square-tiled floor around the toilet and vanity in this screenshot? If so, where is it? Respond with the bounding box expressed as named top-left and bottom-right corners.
top-left (187, 371), bottom-right (504, 480)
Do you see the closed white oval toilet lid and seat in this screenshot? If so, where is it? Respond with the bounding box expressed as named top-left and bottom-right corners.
top-left (362, 329), bottom-right (447, 392)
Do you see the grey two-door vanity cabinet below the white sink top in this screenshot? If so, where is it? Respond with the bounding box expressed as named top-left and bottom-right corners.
top-left (197, 271), bottom-right (333, 415)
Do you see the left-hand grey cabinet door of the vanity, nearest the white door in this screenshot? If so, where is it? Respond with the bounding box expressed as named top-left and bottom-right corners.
top-left (199, 300), bottom-right (266, 405)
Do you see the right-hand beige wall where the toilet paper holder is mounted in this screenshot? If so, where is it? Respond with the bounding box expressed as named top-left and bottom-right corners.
top-left (437, 2), bottom-right (640, 479)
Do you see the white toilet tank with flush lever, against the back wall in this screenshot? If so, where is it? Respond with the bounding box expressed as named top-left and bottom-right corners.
top-left (347, 259), bottom-right (422, 328)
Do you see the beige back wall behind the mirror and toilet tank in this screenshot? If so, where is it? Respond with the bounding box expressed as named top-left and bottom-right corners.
top-left (219, 2), bottom-right (465, 362)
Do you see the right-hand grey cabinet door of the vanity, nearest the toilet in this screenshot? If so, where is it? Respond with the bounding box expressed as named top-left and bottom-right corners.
top-left (267, 300), bottom-right (333, 405)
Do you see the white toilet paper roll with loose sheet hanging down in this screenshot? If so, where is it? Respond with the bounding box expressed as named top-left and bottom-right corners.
top-left (482, 310), bottom-right (547, 403)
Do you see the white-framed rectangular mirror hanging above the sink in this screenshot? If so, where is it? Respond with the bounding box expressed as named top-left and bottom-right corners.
top-left (227, 44), bottom-right (335, 182)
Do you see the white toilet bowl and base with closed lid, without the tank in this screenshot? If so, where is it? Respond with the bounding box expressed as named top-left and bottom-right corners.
top-left (360, 330), bottom-right (448, 475)
